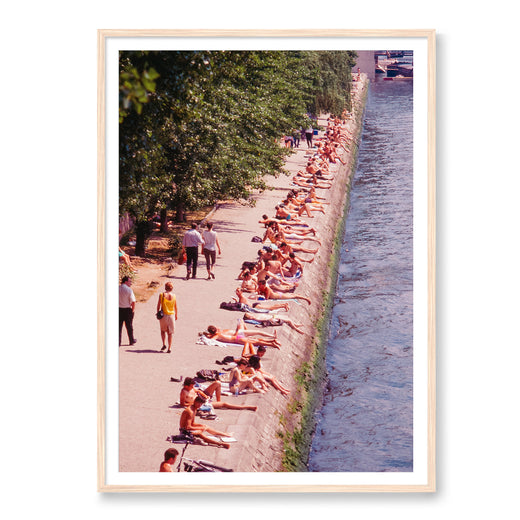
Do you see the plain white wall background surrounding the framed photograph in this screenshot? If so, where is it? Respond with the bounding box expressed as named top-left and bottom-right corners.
top-left (0, 0), bottom-right (520, 520)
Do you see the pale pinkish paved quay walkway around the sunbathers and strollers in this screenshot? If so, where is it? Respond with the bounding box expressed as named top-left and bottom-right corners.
top-left (118, 78), bottom-right (370, 472)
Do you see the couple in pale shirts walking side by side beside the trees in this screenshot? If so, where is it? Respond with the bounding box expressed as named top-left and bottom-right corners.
top-left (182, 222), bottom-right (222, 280)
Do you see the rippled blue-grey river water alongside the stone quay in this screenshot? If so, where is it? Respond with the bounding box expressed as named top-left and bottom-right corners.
top-left (309, 76), bottom-right (413, 472)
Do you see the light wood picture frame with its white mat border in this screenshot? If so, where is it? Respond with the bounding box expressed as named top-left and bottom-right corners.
top-left (97, 29), bottom-right (436, 493)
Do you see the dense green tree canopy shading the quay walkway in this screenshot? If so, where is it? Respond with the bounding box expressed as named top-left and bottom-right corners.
top-left (119, 51), bottom-right (355, 254)
